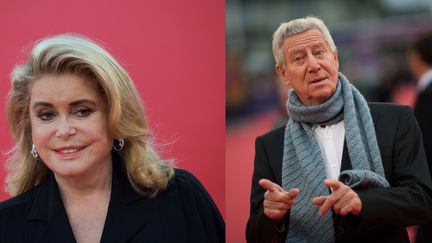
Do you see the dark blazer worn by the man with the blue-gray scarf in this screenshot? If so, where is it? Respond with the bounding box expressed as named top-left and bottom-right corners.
top-left (246, 103), bottom-right (432, 243)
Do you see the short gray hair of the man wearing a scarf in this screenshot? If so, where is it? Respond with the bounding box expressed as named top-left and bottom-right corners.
top-left (272, 16), bottom-right (336, 67)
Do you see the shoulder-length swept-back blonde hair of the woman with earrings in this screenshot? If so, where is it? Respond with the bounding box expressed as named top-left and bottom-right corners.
top-left (7, 34), bottom-right (174, 196)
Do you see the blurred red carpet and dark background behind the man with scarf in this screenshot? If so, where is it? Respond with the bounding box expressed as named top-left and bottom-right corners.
top-left (225, 0), bottom-right (432, 243)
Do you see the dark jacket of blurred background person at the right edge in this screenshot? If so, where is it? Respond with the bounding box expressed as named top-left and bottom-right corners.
top-left (414, 84), bottom-right (432, 243)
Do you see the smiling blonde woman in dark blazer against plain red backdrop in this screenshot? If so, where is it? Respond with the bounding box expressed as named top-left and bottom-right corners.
top-left (0, 35), bottom-right (225, 243)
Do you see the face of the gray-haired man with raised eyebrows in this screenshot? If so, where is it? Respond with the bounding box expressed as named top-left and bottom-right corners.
top-left (276, 29), bottom-right (339, 106)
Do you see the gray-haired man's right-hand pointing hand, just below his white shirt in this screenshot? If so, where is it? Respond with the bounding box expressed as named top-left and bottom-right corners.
top-left (312, 179), bottom-right (362, 216)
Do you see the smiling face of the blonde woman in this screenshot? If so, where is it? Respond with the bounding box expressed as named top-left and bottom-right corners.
top-left (29, 74), bottom-right (112, 178)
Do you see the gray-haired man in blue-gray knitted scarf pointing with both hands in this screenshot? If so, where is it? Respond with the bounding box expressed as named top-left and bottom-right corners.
top-left (246, 17), bottom-right (432, 242)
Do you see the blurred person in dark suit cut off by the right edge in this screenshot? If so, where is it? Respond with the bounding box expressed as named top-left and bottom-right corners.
top-left (409, 33), bottom-right (432, 243)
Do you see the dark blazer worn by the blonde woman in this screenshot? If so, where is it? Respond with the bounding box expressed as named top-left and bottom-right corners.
top-left (0, 155), bottom-right (225, 243)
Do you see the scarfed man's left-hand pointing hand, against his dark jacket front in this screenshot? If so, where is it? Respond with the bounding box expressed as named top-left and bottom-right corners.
top-left (258, 179), bottom-right (299, 221)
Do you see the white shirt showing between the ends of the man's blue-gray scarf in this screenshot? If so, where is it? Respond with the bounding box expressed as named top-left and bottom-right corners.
top-left (312, 120), bottom-right (345, 180)
